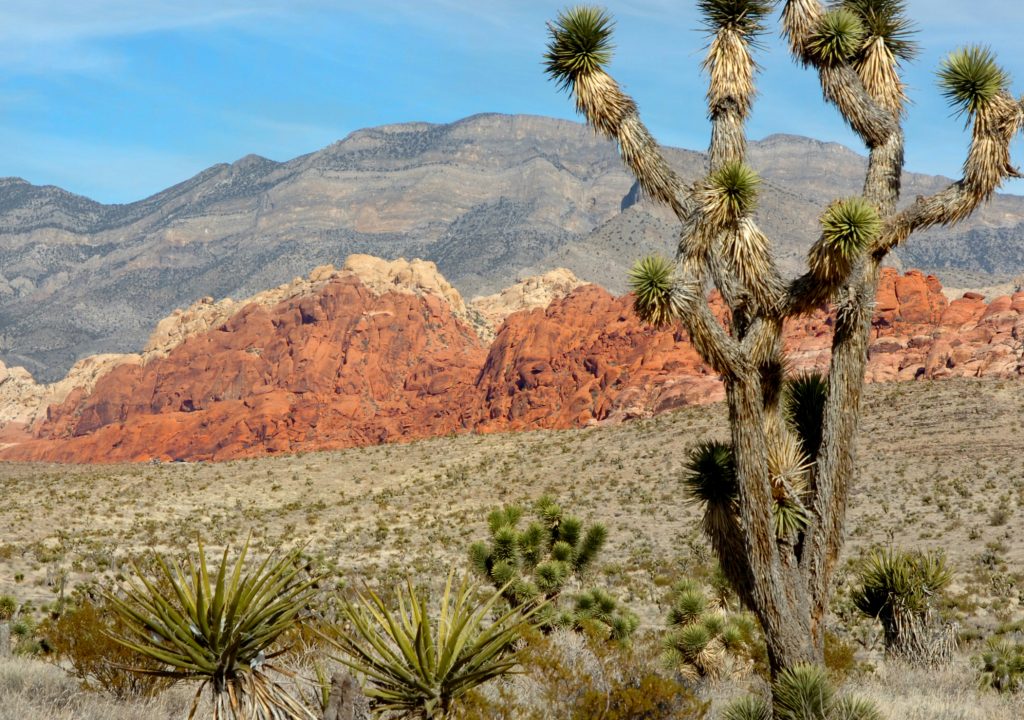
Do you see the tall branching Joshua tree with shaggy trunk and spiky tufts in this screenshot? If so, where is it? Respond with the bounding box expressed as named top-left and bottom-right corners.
top-left (546, 0), bottom-right (1024, 675)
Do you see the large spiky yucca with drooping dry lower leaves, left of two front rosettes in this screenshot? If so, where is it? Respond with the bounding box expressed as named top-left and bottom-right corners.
top-left (106, 540), bottom-right (317, 720)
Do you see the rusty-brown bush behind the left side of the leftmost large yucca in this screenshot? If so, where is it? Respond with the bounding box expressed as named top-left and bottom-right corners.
top-left (39, 599), bottom-right (172, 700)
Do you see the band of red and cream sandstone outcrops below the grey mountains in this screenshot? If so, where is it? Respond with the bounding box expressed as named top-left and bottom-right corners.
top-left (0, 256), bottom-right (1024, 462)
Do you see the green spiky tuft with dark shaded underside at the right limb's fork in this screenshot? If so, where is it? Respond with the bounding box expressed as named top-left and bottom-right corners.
top-left (808, 198), bottom-right (882, 282)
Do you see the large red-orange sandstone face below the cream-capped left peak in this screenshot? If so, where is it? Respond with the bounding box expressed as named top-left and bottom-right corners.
top-left (8, 273), bottom-right (485, 462)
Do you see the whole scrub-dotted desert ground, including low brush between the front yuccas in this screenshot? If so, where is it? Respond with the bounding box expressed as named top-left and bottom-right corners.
top-left (0, 381), bottom-right (1024, 720)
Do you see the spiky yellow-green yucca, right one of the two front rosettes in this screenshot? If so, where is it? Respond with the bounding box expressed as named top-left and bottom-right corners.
top-left (324, 569), bottom-right (541, 720)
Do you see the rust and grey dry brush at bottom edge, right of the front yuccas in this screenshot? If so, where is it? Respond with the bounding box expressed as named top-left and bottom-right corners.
top-left (464, 628), bottom-right (709, 720)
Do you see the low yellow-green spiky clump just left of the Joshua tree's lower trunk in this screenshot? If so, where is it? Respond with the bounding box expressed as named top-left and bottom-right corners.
top-left (663, 580), bottom-right (761, 679)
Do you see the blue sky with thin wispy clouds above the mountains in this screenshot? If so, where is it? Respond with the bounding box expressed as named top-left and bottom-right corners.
top-left (0, 0), bottom-right (1024, 203)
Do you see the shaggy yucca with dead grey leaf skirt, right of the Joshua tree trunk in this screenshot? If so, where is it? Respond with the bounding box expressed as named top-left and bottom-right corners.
top-left (852, 550), bottom-right (956, 663)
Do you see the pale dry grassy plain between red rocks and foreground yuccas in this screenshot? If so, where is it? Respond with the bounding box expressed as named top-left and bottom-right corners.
top-left (0, 380), bottom-right (1024, 718)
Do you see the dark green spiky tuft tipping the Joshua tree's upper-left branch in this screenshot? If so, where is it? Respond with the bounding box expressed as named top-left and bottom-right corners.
top-left (544, 5), bottom-right (614, 89)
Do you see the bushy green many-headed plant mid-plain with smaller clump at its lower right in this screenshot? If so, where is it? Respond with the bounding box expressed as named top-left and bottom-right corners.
top-left (469, 496), bottom-right (639, 640)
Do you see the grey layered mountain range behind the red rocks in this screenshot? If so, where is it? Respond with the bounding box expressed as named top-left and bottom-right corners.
top-left (0, 115), bottom-right (1024, 381)
